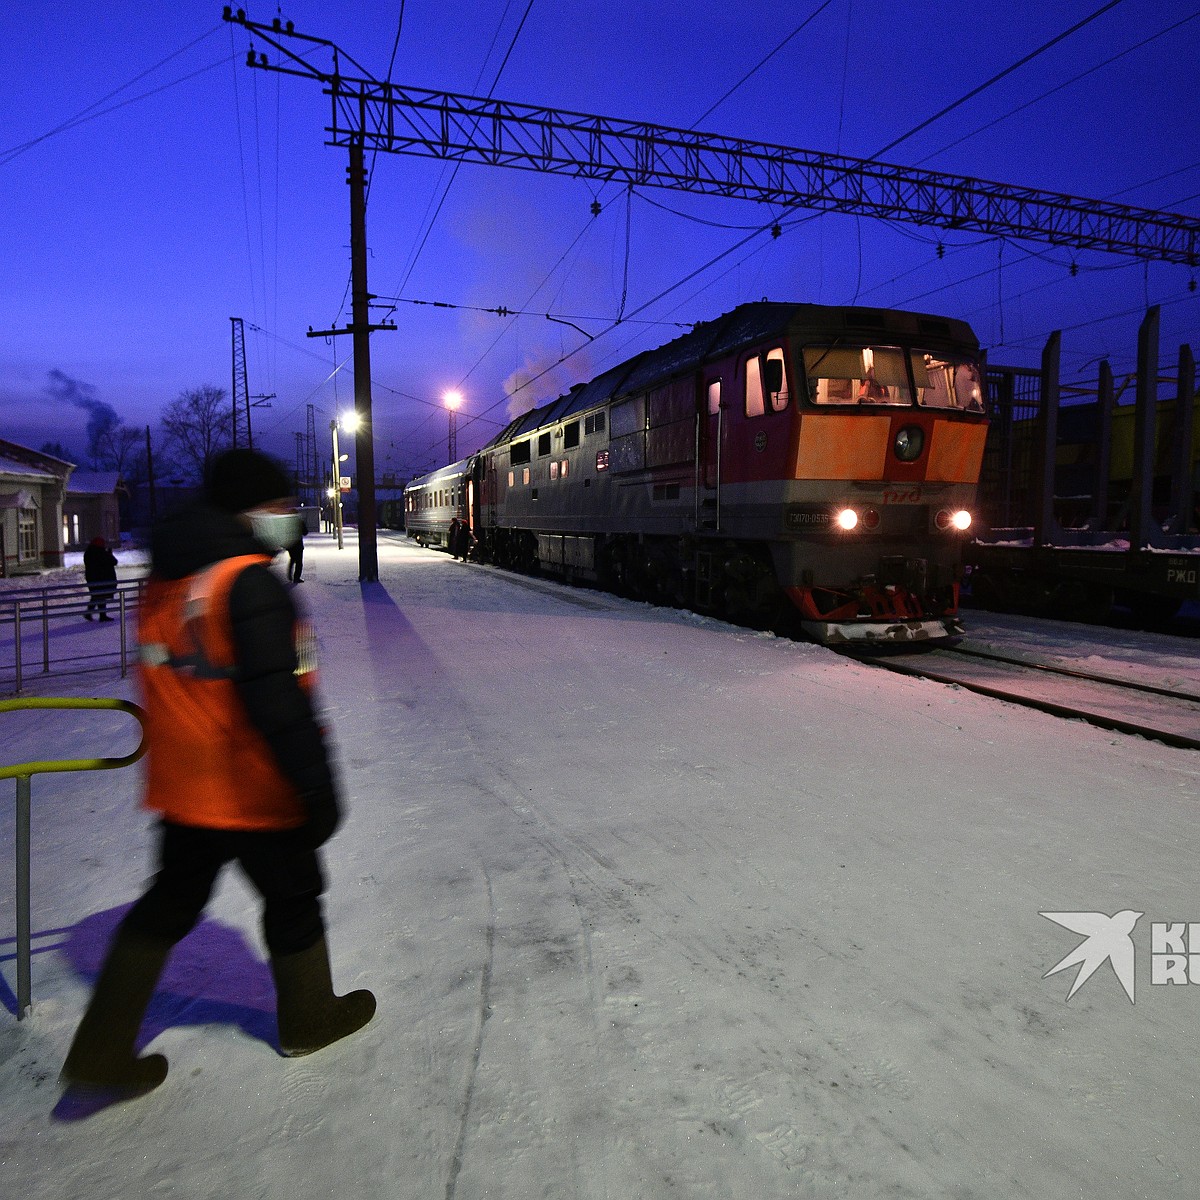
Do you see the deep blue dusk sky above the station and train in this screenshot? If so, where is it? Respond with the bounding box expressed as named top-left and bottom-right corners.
top-left (7, 0), bottom-right (1200, 475)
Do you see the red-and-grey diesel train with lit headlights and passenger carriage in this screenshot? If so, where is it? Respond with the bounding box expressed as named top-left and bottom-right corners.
top-left (406, 301), bottom-right (986, 643)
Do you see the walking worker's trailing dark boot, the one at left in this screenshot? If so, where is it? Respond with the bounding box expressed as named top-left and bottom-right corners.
top-left (61, 929), bottom-right (173, 1096)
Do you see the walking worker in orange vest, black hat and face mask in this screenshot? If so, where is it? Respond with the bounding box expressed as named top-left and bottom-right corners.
top-left (62, 450), bottom-right (376, 1096)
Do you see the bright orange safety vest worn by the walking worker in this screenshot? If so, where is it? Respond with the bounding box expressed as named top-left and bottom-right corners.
top-left (138, 554), bottom-right (314, 830)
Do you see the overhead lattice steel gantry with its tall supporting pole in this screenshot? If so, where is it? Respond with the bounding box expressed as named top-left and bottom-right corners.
top-left (224, 7), bottom-right (1200, 581)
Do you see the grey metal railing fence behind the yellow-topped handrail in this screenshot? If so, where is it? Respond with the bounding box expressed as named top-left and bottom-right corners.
top-left (0, 577), bottom-right (145, 695)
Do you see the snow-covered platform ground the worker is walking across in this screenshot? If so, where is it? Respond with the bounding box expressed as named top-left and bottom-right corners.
top-left (0, 535), bottom-right (1200, 1200)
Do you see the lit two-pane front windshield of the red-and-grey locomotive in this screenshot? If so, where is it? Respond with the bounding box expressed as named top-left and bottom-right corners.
top-left (804, 346), bottom-right (983, 413)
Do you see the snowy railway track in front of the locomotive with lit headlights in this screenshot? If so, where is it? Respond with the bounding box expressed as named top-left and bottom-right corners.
top-left (858, 646), bottom-right (1200, 750)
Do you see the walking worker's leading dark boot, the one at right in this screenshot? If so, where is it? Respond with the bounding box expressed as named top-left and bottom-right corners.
top-left (271, 937), bottom-right (376, 1058)
